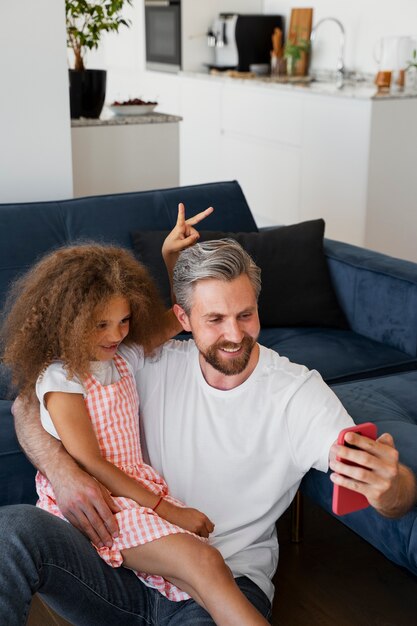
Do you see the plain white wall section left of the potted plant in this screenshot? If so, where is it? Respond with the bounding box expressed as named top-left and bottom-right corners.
top-left (0, 0), bottom-right (72, 202)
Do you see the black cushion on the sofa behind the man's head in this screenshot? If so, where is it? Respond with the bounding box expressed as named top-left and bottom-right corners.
top-left (132, 219), bottom-right (347, 328)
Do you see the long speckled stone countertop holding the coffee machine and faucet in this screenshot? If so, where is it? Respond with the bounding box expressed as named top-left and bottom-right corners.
top-left (181, 72), bottom-right (417, 100)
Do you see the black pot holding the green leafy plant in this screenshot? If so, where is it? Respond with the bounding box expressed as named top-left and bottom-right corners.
top-left (69, 70), bottom-right (106, 119)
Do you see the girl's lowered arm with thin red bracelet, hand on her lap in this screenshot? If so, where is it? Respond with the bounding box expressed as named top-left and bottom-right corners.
top-left (45, 391), bottom-right (214, 537)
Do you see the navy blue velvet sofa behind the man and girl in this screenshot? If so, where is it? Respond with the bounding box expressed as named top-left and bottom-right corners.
top-left (0, 181), bottom-right (417, 574)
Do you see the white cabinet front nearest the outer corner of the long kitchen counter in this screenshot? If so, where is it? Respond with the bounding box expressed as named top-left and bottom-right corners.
top-left (298, 96), bottom-right (370, 245)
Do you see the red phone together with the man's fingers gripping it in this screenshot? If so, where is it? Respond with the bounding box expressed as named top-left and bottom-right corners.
top-left (330, 422), bottom-right (405, 516)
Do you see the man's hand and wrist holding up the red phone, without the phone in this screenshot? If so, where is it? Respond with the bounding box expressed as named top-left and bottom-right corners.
top-left (330, 432), bottom-right (417, 518)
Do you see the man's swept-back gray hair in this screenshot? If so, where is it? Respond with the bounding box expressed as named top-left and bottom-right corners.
top-left (173, 239), bottom-right (261, 315)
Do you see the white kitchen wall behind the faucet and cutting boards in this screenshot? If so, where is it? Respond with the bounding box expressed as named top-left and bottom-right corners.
top-left (263, 0), bottom-right (417, 73)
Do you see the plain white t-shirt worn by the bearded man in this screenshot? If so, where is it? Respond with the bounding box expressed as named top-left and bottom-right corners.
top-left (136, 340), bottom-right (353, 601)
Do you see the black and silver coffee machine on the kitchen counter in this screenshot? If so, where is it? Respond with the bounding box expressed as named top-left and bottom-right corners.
top-left (207, 13), bottom-right (284, 72)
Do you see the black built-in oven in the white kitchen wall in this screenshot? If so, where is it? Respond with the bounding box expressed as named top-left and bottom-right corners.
top-left (145, 0), bottom-right (181, 72)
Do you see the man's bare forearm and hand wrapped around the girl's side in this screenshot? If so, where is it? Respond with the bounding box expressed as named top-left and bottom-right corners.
top-left (12, 398), bottom-right (118, 547)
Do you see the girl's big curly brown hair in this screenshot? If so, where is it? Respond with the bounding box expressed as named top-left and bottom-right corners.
top-left (0, 244), bottom-right (165, 397)
